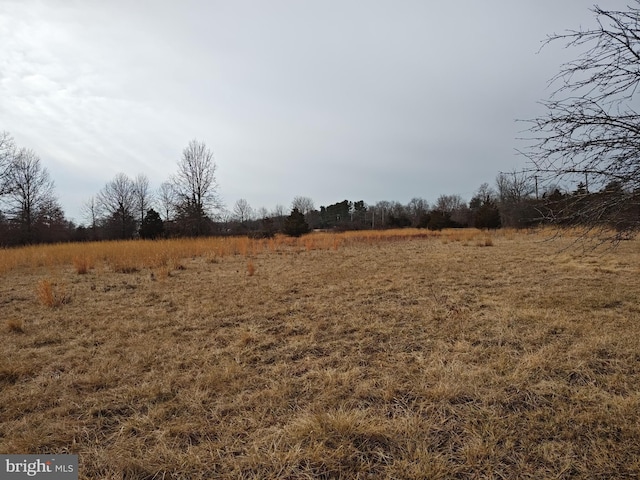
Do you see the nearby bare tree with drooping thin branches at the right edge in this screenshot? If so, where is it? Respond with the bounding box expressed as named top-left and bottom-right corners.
top-left (523, 0), bottom-right (640, 238)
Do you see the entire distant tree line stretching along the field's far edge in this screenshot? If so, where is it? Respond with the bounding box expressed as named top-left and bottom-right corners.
top-left (0, 128), bottom-right (633, 246)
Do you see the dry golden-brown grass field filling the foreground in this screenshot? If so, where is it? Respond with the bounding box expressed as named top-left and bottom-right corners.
top-left (0, 230), bottom-right (640, 479)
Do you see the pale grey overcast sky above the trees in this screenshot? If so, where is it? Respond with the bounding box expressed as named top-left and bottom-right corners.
top-left (0, 0), bottom-right (626, 221)
